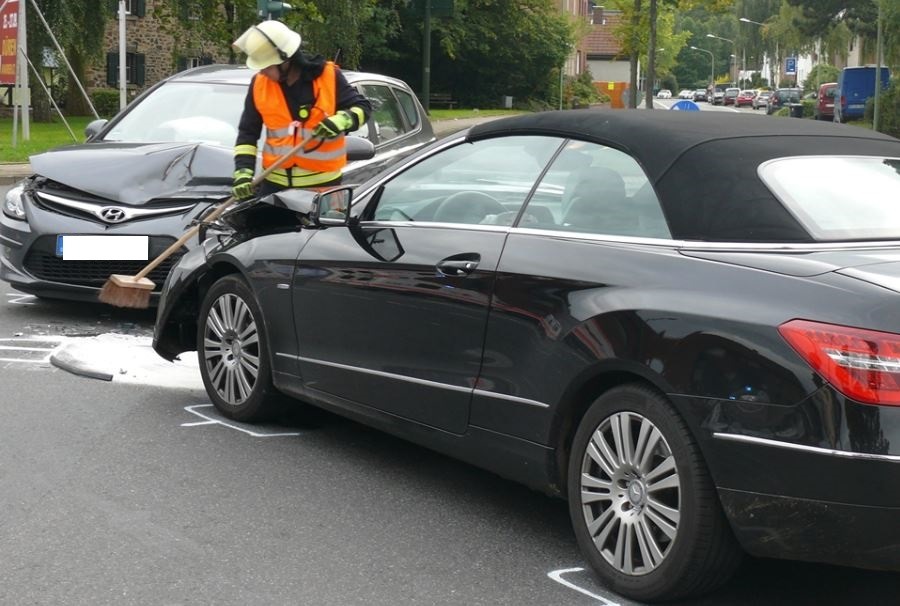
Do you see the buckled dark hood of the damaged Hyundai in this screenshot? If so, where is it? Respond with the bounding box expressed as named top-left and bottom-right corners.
top-left (30, 143), bottom-right (234, 205)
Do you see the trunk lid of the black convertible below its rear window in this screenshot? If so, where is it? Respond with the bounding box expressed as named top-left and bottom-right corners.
top-left (681, 247), bottom-right (900, 292)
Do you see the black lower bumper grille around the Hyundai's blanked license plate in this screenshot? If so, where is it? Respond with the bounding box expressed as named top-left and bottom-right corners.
top-left (25, 236), bottom-right (187, 291)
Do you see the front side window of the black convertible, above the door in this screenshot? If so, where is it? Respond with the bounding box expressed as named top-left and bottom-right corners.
top-left (365, 137), bottom-right (562, 225)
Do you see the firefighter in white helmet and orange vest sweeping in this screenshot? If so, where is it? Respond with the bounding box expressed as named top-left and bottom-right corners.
top-left (232, 21), bottom-right (372, 200)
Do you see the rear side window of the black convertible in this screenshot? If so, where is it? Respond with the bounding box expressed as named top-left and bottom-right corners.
top-left (520, 141), bottom-right (670, 238)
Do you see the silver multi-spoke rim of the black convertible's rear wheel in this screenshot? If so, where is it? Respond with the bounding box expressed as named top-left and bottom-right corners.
top-left (581, 412), bottom-right (681, 576)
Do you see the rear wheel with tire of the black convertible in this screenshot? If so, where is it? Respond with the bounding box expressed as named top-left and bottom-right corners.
top-left (567, 384), bottom-right (742, 601)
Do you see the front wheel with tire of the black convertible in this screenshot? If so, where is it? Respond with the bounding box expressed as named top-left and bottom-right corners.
top-left (197, 276), bottom-right (286, 422)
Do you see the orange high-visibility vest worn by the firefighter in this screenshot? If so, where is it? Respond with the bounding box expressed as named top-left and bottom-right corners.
top-left (253, 61), bottom-right (347, 176)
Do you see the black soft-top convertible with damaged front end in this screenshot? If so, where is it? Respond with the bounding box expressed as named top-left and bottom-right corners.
top-left (153, 110), bottom-right (900, 600)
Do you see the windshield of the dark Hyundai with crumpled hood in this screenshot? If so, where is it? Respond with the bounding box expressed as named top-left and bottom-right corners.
top-left (103, 82), bottom-right (247, 147)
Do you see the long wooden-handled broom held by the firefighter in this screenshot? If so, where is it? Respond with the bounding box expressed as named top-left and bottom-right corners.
top-left (98, 136), bottom-right (312, 309)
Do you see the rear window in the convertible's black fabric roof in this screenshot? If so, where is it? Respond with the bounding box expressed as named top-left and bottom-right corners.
top-left (759, 156), bottom-right (900, 241)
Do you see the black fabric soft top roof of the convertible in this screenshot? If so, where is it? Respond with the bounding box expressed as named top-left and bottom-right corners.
top-left (468, 110), bottom-right (900, 242)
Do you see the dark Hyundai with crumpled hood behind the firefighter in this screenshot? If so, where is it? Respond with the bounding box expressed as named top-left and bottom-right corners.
top-left (0, 65), bottom-right (434, 301)
